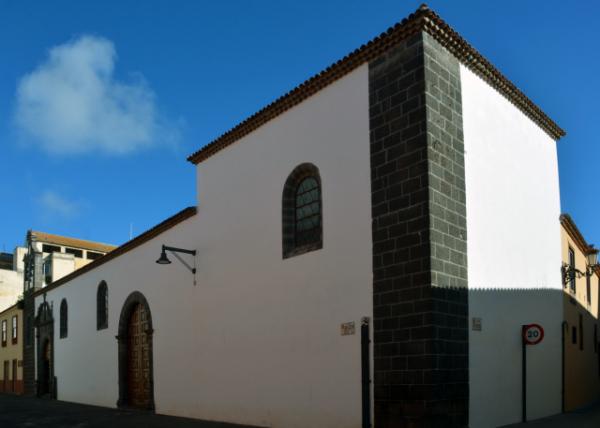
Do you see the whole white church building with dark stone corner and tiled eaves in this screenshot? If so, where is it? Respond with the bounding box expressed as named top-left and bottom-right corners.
top-left (26, 6), bottom-right (564, 428)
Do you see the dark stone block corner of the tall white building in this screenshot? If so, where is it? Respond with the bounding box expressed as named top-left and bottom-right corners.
top-left (369, 31), bottom-right (469, 428)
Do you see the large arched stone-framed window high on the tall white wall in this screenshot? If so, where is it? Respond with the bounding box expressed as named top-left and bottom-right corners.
top-left (282, 163), bottom-right (323, 259)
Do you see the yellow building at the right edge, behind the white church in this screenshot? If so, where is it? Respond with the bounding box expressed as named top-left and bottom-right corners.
top-left (560, 214), bottom-right (600, 411)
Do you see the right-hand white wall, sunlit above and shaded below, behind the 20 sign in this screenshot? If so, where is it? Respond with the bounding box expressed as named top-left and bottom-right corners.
top-left (461, 66), bottom-right (562, 428)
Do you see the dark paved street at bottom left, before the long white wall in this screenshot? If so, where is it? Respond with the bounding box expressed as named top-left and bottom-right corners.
top-left (0, 394), bottom-right (255, 428)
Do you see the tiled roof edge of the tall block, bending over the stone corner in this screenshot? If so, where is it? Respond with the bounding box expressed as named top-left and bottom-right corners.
top-left (187, 4), bottom-right (565, 164)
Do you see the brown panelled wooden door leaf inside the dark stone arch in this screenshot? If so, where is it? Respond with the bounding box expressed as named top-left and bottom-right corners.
top-left (127, 303), bottom-right (151, 409)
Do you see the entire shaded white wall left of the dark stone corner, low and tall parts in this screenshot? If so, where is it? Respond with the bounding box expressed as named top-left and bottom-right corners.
top-left (37, 65), bottom-right (372, 428)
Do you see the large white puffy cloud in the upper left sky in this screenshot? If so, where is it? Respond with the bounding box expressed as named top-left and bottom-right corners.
top-left (15, 36), bottom-right (177, 154)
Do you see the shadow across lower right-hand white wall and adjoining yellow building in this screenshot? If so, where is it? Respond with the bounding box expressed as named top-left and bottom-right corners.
top-left (469, 288), bottom-right (600, 428)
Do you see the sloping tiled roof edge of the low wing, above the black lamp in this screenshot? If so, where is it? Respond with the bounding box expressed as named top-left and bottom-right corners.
top-left (34, 206), bottom-right (196, 296)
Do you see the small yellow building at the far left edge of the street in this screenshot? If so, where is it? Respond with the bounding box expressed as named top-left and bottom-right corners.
top-left (0, 304), bottom-right (23, 394)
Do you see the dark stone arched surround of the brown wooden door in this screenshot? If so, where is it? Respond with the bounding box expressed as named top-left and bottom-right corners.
top-left (116, 291), bottom-right (155, 411)
